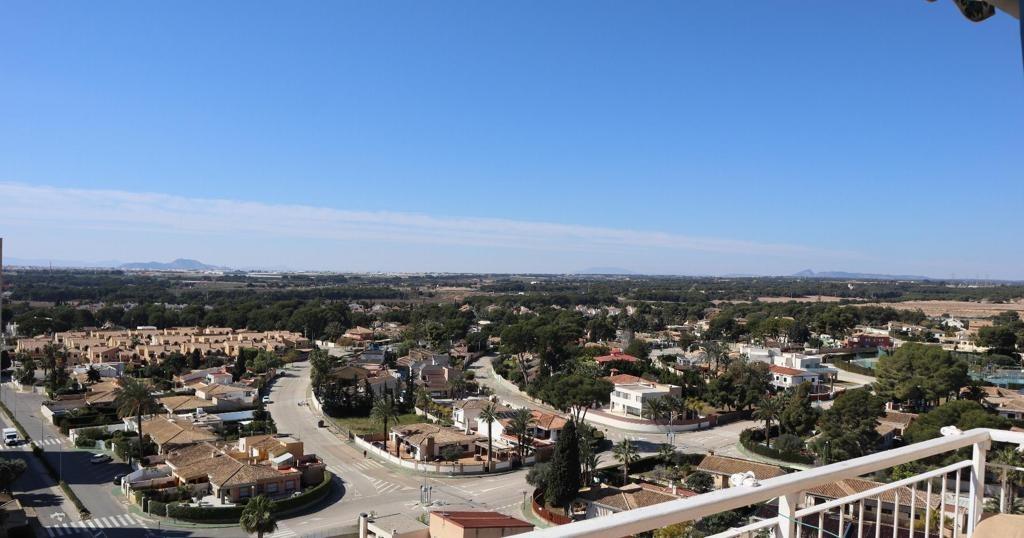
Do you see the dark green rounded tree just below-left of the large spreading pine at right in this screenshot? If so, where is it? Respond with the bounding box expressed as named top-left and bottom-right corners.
top-left (817, 387), bottom-right (885, 463)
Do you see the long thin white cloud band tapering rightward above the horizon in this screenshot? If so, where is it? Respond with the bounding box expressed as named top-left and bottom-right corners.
top-left (0, 182), bottom-right (855, 270)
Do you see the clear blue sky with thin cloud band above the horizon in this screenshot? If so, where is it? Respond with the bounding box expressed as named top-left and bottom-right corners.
top-left (0, 0), bottom-right (1024, 278)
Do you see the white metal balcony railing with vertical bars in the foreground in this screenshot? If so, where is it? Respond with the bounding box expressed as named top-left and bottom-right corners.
top-left (523, 428), bottom-right (1024, 538)
